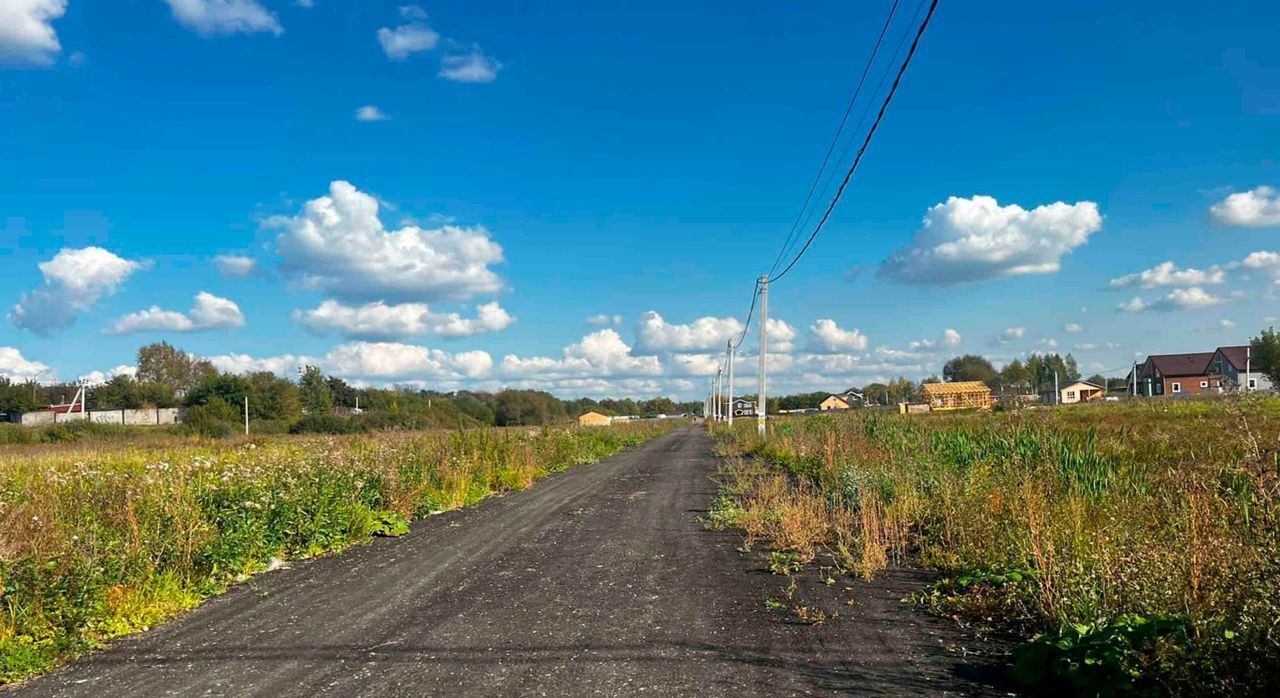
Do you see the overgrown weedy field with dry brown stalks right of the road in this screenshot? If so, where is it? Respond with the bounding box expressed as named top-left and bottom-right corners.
top-left (712, 398), bottom-right (1280, 695)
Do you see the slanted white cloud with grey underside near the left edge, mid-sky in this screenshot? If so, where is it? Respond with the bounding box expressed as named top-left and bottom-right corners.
top-left (9, 247), bottom-right (147, 337)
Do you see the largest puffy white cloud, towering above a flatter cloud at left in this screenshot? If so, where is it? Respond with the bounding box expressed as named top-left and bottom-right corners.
top-left (269, 181), bottom-right (503, 302)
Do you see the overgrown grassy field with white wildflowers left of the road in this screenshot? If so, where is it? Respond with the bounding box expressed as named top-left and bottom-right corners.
top-left (0, 420), bottom-right (676, 683)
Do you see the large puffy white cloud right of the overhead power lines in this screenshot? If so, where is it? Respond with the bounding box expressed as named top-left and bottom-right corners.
top-left (879, 196), bottom-right (1102, 286)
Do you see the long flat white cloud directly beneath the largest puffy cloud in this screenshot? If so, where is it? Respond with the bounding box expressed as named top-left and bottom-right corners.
top-left (293, 300), bottom-right (516, 339)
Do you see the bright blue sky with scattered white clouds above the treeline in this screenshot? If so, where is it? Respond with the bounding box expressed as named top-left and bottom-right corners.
top-left (0, 0), bottom-right (1280, 397)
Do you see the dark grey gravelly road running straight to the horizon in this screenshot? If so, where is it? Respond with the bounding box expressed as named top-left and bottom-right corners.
top-left (14, 428), bottom-right (995, 698)
